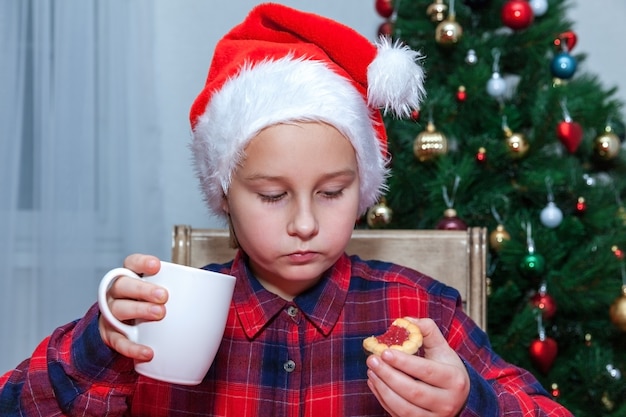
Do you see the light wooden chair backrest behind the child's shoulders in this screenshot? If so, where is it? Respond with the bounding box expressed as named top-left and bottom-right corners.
top-left (172, 225), bottom-right (487, 329)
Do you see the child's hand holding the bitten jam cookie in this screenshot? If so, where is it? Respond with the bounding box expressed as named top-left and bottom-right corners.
top-left (360, 318), bottom-right (470, 416)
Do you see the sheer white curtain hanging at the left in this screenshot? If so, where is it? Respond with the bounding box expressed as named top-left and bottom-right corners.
top-left (0, 0), bottom-right (163, 374)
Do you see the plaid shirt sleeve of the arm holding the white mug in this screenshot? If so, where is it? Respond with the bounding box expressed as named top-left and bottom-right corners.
top-left (0, 305), bottom-right (137, 416)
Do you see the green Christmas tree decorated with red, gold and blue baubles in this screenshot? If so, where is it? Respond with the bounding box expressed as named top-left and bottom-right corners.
top-left (369, 0), bottom-right (626, 416)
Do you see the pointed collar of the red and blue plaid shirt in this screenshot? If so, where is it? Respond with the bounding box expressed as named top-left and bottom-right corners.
top-left (230, 251), bottom-right (351, 338)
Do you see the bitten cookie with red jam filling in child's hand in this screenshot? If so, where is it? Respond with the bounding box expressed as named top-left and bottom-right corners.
top-left (363, 318), bottom-right (423, 355)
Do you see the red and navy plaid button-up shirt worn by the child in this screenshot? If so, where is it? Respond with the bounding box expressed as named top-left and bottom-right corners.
top-left (0, 250), bottom-right (571, 417)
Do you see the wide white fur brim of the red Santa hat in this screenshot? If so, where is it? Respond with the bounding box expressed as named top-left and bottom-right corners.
top-left (191, 55), bottom-right (386, 215)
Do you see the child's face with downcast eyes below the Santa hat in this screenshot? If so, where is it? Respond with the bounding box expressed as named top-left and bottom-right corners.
top-left (223, 123), bottom-right (359, 299)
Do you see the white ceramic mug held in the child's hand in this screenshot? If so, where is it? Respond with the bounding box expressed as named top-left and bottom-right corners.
top-left (98, 262), bottom-right (235, 385)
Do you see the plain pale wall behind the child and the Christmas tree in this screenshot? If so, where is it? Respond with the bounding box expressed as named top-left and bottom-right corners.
top-left (155, 0), bottom-right (626, 258)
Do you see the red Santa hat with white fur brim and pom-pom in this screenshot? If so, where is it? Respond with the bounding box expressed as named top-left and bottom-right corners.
top-left (190, 3), bottom-right (424, 215)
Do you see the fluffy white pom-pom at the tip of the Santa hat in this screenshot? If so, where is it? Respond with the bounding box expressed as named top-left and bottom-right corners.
top-left (367, 36), bottom-right (426, 117)
